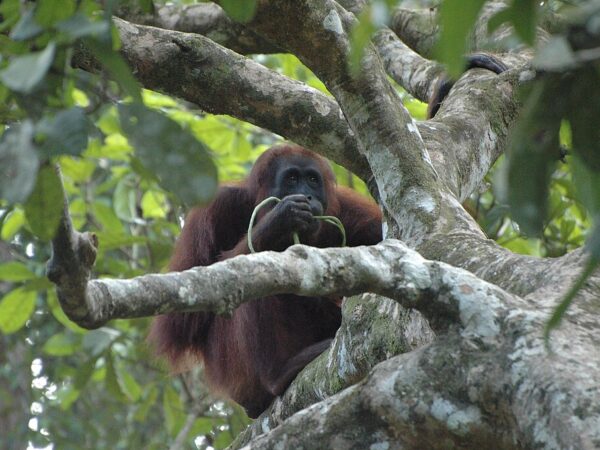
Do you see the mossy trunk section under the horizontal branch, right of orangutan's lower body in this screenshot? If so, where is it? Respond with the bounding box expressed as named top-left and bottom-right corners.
top-left (237, 294), bottom-right (435, 436)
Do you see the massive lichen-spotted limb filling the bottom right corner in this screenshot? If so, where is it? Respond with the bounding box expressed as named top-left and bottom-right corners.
top-left (234, 305), bottom-right (600, 449)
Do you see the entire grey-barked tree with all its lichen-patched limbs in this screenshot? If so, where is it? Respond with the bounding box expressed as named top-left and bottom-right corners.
top-left (49, 0), bottom-right (600, 449)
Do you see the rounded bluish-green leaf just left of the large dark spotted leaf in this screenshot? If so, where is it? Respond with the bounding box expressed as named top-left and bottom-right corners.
top-left (36, 107), bottom-right (90, 157)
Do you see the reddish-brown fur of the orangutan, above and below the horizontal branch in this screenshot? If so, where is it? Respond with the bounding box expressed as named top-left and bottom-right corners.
top-left (150, 145), bottom-right (381, 417)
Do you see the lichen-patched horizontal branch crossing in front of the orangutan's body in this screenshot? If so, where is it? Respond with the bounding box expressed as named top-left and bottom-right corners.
top-left (49, 227), bottom-right (516, 329)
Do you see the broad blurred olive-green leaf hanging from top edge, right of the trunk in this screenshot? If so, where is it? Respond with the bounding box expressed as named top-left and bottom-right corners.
top-left (434, 0), bottom-right (485, 78)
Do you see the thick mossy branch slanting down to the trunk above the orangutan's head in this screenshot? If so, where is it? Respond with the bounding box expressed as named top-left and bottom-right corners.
top-left (73, 19), bottom-right (371, 180)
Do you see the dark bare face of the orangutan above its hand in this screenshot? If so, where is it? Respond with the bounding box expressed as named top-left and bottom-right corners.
top-left (270, 156), bottom-right (327, 216)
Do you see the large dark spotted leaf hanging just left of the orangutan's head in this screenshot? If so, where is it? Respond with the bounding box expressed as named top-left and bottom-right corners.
top-left (119, 105), bottom-right (217, 205)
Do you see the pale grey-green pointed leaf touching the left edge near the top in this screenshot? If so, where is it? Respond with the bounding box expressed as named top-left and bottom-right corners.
top-left (0, 41), bottom-right (56, 94)
